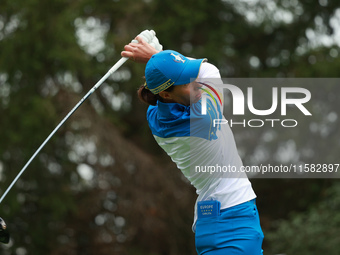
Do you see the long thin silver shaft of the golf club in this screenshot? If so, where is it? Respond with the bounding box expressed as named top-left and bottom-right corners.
top-left (0, 57), bottom-right (128, 203)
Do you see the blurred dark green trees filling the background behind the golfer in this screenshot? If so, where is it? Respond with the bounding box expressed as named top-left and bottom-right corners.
top-left (0, 0), bottom-right (340, 255)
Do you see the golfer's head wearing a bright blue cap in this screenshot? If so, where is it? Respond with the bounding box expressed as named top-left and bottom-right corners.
top-left (145, 50), bottom-right (205, 105)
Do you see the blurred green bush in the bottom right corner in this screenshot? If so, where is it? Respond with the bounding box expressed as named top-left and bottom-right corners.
top-left (267, 182), bottom-right (340, 255)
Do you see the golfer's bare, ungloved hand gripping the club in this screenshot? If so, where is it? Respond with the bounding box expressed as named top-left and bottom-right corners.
top-left (121, 36), bottom-right (160, 63)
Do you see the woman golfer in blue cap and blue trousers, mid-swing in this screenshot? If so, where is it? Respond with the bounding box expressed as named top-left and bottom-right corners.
top-left (122, 37), bottom-right (263, 255)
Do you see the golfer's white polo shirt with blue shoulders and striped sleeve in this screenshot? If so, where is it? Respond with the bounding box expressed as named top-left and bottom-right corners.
top-left (147, 63), bottom-right (256, 232)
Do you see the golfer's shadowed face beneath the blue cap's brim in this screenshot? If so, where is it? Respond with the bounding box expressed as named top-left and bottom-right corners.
top-left (171, 81), bottom-right (202, 106)
